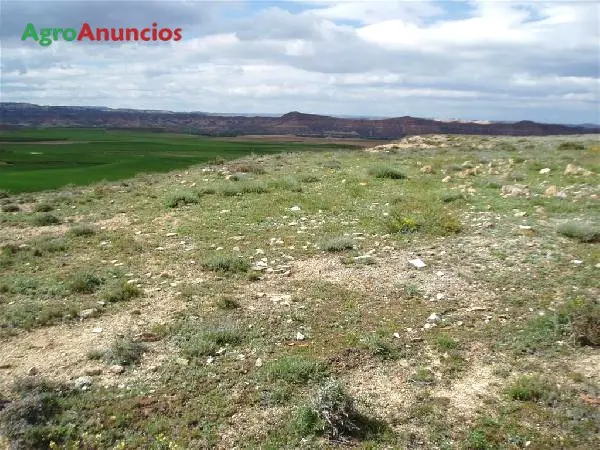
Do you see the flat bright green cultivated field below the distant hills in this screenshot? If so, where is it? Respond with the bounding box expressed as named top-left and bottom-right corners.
top-left (0, 128), bottom-right (358, 193)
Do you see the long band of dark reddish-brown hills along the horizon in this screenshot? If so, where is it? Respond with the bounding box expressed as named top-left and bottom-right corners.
top-left (0, 103), bottom-right (600, 139)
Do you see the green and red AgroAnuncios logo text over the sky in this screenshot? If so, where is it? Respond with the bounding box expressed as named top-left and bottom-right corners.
top-left (21, 22), bottom-right (182, 47)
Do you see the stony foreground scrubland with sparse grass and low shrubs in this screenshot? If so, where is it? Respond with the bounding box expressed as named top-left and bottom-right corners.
top-left (0, 136), bottom-right (600, 449)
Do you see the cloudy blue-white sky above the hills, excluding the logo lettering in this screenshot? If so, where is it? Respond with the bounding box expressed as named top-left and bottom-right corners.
top-left (0, 0), bottom-right (600, 123)
